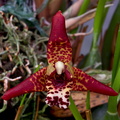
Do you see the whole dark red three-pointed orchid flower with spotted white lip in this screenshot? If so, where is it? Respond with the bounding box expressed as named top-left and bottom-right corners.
top-left (2, 11), bottom-right (117, 109)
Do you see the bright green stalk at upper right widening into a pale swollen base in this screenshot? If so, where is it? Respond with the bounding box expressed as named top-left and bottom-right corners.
top-left (84, 0), bottom-right (106, 67)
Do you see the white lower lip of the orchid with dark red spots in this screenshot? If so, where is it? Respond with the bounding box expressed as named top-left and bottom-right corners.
top-left (45, 82), bottom-right (71, 109)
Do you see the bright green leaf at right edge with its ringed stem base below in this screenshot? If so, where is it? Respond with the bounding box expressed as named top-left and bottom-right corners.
top-left (105, 27), bottom-right (120, 120)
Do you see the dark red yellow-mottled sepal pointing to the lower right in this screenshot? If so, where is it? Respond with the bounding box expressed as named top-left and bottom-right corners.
top-left (73, 68), bottom-right (118, 96)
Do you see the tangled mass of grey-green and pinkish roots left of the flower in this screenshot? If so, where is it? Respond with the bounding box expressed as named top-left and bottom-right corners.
top-left (0, 12), bottom-right (48, 117)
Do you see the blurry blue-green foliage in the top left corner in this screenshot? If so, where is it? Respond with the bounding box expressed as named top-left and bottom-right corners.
top-left (0, 0), bottom-right (48, 37)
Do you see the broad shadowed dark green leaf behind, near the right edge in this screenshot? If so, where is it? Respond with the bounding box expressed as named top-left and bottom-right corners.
top-left (101, 2), bottom-right (120, 70)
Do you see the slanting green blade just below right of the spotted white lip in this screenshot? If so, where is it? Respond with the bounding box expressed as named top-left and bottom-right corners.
top-left (69, 96), bottom-right (84, 120)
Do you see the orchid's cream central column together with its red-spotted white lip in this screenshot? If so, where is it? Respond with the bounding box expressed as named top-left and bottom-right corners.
top-left (45, 61), bottom-right (73, 109)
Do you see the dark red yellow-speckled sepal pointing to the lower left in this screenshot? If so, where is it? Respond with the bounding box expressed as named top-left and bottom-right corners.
top-left (2, 68), bottom-right (46, 100)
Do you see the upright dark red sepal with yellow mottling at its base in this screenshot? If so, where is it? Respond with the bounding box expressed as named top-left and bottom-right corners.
top-left (47, 11), bottom-right (72, 63)
